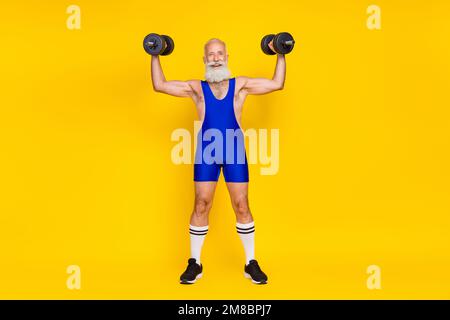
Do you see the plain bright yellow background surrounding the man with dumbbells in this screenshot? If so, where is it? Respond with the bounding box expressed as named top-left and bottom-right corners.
top-left (0, 0), bottom-right (450, 299)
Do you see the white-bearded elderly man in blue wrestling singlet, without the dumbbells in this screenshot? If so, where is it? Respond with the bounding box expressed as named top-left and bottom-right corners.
top-left (151, 38), bottom-right (286, 284)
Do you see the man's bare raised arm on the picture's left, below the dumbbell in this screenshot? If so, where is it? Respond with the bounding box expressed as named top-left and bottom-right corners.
top-left (151, 56), bottom-right (194, 97)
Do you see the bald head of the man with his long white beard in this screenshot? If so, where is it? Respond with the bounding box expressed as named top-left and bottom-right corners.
top-left (203, 41), bottom-right (230, 82)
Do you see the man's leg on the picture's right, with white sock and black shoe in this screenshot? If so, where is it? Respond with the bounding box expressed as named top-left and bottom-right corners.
top-left (227, 182), bottom-right (267, 284)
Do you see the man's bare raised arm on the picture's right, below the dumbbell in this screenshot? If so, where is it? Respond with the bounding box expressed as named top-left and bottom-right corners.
top-left (239, 54), bottom-right (286, 94)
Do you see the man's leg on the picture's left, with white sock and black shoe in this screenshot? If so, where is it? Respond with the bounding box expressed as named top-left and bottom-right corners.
top-left (180, 181), bottom-right (217, 284)
